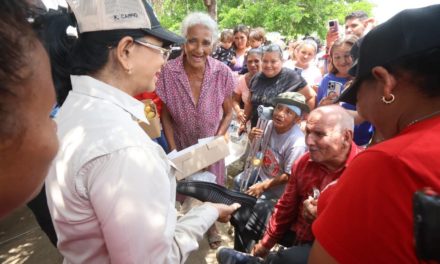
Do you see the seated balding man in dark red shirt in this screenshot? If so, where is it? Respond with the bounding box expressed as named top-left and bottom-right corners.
top-left (217, 105), bottom-right (362, 263)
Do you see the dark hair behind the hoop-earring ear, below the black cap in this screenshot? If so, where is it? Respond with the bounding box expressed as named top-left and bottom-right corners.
top-left (384, 47), bottom-right (440, 97)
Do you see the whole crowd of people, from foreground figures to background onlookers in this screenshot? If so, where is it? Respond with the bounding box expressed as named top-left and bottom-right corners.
top-left (0, 0), bottom-right (440, 264)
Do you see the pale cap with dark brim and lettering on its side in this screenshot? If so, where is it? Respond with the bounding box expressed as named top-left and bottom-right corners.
top-left (67, 0), bottom-right (185, 46)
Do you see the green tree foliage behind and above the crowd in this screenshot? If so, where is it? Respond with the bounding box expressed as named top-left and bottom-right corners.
top-left (156, 0), bottom-right (373, 39)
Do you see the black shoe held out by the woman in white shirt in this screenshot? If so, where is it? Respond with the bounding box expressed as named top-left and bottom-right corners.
top-left (177, 181), bottom-right (257, 229)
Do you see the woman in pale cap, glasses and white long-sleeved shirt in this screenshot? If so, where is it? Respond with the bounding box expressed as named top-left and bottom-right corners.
top-left (46, 0), bottom-right (241, 263)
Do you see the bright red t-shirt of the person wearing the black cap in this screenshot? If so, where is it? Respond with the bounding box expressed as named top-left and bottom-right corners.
top-left (313, 117), bottom-right (440, 263)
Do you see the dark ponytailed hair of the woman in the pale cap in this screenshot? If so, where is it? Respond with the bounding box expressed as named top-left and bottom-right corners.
top-left (34, 8), bottom-right (145, 105)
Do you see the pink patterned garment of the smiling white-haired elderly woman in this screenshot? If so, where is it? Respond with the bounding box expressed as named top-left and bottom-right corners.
top-left (156, 56), bottom-right (236, 184)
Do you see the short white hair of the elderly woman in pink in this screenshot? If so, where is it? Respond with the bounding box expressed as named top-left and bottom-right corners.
top-left (180, 12), bottom-right (218, 43)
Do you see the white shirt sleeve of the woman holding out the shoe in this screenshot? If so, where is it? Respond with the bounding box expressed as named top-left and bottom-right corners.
top-left (84, 147), bottom-right (218, 263)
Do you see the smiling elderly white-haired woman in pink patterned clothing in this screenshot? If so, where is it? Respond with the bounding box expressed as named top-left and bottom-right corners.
top-left (157, 12), bottom-right (236, 248)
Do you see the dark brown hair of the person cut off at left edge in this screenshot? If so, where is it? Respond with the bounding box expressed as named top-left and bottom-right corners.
top-left (0, 0), bottom-right (38, 140)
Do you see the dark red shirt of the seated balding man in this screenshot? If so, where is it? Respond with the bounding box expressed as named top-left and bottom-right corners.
top-left (261, 143), bottom-right (362, 248)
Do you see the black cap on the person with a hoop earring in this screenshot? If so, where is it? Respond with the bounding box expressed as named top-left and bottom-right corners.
top-left (339, 5), bottom-right (440, 104)
